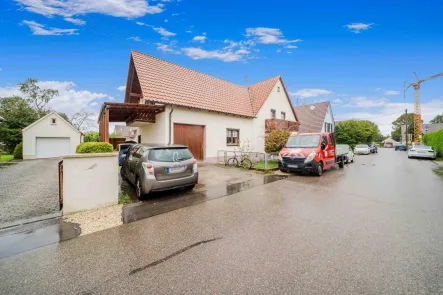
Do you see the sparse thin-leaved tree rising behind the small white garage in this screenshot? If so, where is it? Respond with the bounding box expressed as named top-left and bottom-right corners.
top-left (18, 78), bottom-right (58, 118)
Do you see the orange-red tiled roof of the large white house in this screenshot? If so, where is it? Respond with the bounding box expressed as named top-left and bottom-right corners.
top-left (131, 51), bottom-right (290, 117)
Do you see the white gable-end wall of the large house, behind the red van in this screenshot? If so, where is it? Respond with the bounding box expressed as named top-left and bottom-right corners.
top-left (253, 80), bottom-right (296, 153)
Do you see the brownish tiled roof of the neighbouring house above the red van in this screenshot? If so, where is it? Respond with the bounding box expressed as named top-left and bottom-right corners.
top-left (294, 101), bottom-right (330, 133)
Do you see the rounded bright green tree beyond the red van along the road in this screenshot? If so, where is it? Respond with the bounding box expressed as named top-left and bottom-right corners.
top-left (335, 120), bottom-right (380, 146)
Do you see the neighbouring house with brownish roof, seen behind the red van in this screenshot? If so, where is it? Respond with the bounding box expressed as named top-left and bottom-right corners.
top-left (294, 101), bottom-right (335, 133)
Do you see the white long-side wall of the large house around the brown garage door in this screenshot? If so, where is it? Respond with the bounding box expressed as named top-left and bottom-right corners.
top-left (139, 106), bottom-right (256, 161)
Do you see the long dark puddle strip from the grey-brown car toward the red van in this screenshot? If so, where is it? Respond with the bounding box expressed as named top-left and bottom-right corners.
top-left (122, 175), bottom-right (288, 223)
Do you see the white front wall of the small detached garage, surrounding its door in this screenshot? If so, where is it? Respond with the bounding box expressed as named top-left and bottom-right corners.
top-left (23, 113), bottom-right (82, 160)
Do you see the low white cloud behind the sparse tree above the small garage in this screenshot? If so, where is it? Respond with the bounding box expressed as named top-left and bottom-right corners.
top-left (0, 81), bottom-right (113, 119)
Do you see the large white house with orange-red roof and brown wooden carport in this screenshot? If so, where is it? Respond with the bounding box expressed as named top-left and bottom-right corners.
top-left (99, 51), bottom-right (298, 161)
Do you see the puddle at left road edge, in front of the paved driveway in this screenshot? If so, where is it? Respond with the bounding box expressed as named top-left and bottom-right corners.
top-left (0, 222), bottom-right (81, 259)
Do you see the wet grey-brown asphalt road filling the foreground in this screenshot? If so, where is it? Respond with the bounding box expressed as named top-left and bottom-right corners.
top-left (0, 149), bottom-right (443, 294)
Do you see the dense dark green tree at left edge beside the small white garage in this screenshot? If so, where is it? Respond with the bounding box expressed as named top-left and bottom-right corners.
top-left (0, 96), bottom-right (38, 152)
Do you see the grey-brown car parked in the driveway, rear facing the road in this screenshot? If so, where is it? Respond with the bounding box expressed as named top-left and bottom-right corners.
top-left (120, 144), bottom-right (198, 199)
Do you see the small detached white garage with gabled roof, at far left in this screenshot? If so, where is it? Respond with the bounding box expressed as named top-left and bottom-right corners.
top-left (22, 112), bottom-right (83, 160)
